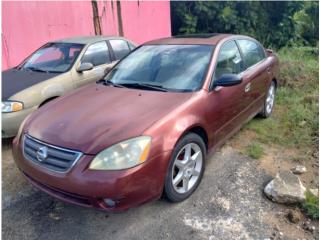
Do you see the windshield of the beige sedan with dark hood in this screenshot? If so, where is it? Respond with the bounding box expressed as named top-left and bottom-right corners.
top-left (19, 43), bottom-right (84, 73)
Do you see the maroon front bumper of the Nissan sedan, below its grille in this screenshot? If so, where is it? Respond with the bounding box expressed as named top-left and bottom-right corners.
top-left (13, 138), bottom-right (171, 211)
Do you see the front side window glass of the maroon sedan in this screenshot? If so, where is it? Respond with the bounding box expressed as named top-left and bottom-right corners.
top-left (213, 41), bottom-right (244, 81)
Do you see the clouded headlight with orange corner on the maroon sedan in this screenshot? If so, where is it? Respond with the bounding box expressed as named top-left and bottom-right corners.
top-left (89, 136), bottom-right (151, 170)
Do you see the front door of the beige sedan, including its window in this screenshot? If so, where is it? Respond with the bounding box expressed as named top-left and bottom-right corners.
top-left (73, 41), bottom-right (113, 87)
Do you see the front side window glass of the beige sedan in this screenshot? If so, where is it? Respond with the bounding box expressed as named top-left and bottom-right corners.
top-left (81, 42), bottom-right (110, 66)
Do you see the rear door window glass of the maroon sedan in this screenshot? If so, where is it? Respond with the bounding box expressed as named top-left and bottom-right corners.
top-left (237, 39), bottom-right (265, 68)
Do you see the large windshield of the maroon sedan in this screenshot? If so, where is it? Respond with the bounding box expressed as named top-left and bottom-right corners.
top-left (105, 45), bottom-right (214, 92)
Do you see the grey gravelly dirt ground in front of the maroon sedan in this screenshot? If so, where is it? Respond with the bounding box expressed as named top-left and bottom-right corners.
top-left (2, 136), bottom-right (319, 240)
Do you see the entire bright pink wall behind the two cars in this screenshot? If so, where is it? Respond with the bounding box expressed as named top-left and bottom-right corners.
top-left (2, 0), bottom-right (171, 69)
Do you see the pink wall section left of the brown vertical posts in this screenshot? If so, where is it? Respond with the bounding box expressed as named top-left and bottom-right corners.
top-left (2, 1), bottom-right (94, 69)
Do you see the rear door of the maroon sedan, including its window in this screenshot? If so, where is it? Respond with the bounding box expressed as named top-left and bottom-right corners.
top-left (236, 39), bottom-right (270, 115)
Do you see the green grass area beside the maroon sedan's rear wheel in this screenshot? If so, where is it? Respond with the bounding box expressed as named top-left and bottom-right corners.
top-left (245, 47), bottom-right (319, 155)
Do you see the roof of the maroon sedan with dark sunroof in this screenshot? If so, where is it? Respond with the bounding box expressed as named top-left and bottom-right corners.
top-left (145, 33), bottom-right (238, 45)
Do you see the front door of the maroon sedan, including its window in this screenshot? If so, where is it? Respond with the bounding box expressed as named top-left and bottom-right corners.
top-left (206, 40), bottom-right (247, 145)
